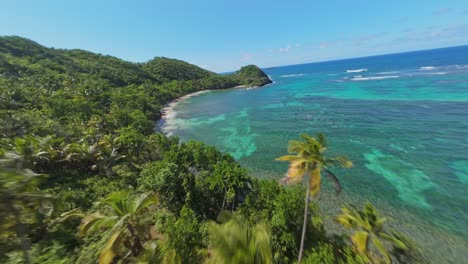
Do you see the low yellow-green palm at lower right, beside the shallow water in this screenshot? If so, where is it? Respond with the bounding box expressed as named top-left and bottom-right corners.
top-left (336, 203), bottom-right (407, 263)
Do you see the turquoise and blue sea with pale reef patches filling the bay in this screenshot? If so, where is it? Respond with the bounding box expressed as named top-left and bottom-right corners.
top-left (161, 46), bottom-right (468, 263)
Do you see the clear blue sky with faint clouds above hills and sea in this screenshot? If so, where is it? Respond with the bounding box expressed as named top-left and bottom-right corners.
top-left (0, 0), bottom-right (468, 72)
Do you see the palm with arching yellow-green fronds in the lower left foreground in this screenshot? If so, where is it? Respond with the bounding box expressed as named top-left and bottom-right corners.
top-left (80, 191), bottom-right (158, 263)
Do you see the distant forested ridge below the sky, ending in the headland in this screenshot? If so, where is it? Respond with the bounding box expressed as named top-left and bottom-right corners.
top-left (0, 37), bottom-right (271, 89)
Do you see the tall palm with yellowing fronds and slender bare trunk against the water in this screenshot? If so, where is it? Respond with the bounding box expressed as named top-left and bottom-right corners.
top-left (276, 134), bottom-right (353, 263)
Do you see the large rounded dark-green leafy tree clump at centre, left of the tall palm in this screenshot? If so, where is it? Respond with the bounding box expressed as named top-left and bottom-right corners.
top-left (138, 142), bottom-right (250, 219)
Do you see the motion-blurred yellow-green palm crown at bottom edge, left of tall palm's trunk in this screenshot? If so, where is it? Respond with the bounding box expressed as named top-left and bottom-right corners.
top-left (209, 219), bottom-right (273, 264)
